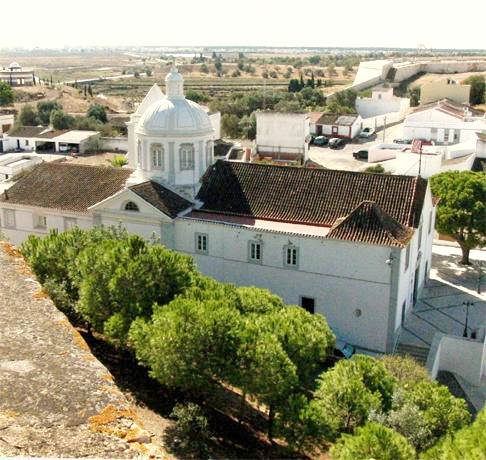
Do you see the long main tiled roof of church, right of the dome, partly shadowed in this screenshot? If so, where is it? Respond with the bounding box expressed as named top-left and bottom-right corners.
top-left (197, 160), bottom-right (427, 227)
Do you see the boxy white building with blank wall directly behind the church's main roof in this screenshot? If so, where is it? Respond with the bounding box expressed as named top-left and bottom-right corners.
top-left (254, 112), bottom-right (310, 163)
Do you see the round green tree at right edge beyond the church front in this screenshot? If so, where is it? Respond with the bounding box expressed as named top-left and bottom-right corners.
top-left (430, 171), bottom-right (486, 265)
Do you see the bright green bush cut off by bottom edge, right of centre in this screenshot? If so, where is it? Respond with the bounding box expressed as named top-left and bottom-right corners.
top-left (331, 423), bottom-right (415, 460)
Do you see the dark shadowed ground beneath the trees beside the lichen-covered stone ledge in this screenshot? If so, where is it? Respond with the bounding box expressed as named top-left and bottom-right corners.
top-left (80, 329), bottom-right (306, 459)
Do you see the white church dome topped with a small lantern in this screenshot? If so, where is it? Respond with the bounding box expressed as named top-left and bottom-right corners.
top-left (136, 67), bottom-right (213, 137)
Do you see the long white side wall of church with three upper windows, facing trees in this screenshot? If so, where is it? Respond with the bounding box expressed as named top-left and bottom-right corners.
top-left (175, 219), bottom-right (402, 351)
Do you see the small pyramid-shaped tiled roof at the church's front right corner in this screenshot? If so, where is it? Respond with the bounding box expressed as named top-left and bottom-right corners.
top-left (327, 201), bottom-right (413, 247)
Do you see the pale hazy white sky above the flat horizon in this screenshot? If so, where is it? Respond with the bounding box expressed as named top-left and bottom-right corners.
top-left (0, 0), bottom-right (486, 48)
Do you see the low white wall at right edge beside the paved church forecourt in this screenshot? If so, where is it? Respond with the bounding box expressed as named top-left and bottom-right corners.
top-left (427, 333), bottom-right (486, 385)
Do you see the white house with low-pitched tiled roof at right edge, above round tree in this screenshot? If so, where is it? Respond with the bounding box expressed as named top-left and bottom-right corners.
top-left (403, 99), bottom-right (486, 144)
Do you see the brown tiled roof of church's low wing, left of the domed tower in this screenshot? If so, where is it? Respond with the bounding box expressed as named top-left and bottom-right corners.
top-left (0, 162), bottom-right (132, 212)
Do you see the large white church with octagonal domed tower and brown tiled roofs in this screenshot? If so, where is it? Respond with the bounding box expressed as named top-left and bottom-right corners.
top-left (0, 68), bottom-right (435, 352)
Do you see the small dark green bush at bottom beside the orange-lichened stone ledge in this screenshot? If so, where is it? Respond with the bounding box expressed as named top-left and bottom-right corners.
top-left (164, 403), bottom-right (211, 459)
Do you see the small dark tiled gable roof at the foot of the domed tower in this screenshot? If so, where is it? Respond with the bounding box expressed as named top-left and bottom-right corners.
top-left (128, 181), bottom-right (192, 217)
